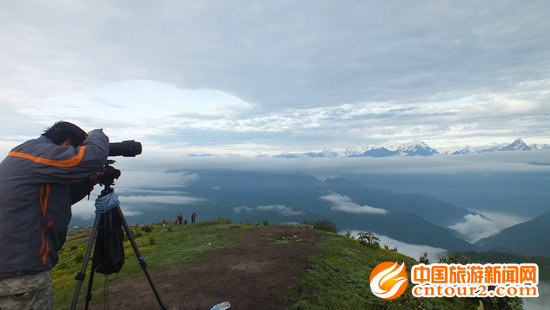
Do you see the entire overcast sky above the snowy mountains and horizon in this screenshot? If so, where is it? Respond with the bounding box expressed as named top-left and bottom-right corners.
top-left (0, 0), bottom-right (550, 154)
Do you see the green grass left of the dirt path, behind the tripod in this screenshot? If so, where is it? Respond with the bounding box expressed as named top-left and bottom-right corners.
top-left (51, 219), bottom-right (244, 309)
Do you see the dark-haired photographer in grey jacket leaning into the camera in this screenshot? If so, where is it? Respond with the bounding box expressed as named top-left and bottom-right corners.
top-left (0, 122), bottom-right (109, 310)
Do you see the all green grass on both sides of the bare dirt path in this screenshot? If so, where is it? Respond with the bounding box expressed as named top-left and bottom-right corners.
top-left (52, 219), bottom-right (488, 309)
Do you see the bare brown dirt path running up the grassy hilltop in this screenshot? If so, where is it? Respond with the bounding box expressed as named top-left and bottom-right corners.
top-left (91, 225), bottom-right (320, 310)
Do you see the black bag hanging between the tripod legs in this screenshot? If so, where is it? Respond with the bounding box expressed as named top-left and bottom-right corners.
top-left (93, 207), bottom-right (124, 275)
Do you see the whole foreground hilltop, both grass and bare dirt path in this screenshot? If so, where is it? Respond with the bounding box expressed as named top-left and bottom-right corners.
top-left (52, 219), bottom-right (502, 309)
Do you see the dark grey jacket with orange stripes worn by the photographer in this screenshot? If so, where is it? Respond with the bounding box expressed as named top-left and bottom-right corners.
top-left (0, 130), bottom-right (109, 279)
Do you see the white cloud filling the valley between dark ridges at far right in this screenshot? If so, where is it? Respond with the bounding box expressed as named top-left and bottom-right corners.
top-left (449, 211), bottom-right (529, 243)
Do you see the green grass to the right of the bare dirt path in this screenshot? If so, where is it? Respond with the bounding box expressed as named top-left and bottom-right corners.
top-left (289, 233), bottom-right (479, 310)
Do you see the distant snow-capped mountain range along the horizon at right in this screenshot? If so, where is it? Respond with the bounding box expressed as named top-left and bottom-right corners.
top-left (277, 138), bottom-right (550, 158)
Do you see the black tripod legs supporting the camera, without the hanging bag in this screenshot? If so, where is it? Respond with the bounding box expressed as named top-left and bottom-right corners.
top-left (71, 183), bottom-right (166, 310)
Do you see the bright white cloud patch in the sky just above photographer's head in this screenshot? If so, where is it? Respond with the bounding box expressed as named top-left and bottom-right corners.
top-left (1, 80), bottom-right (253, 140)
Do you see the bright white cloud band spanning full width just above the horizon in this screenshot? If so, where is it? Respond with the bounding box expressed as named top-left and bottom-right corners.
top-left (0, 80), bottom-right (550, 155)
